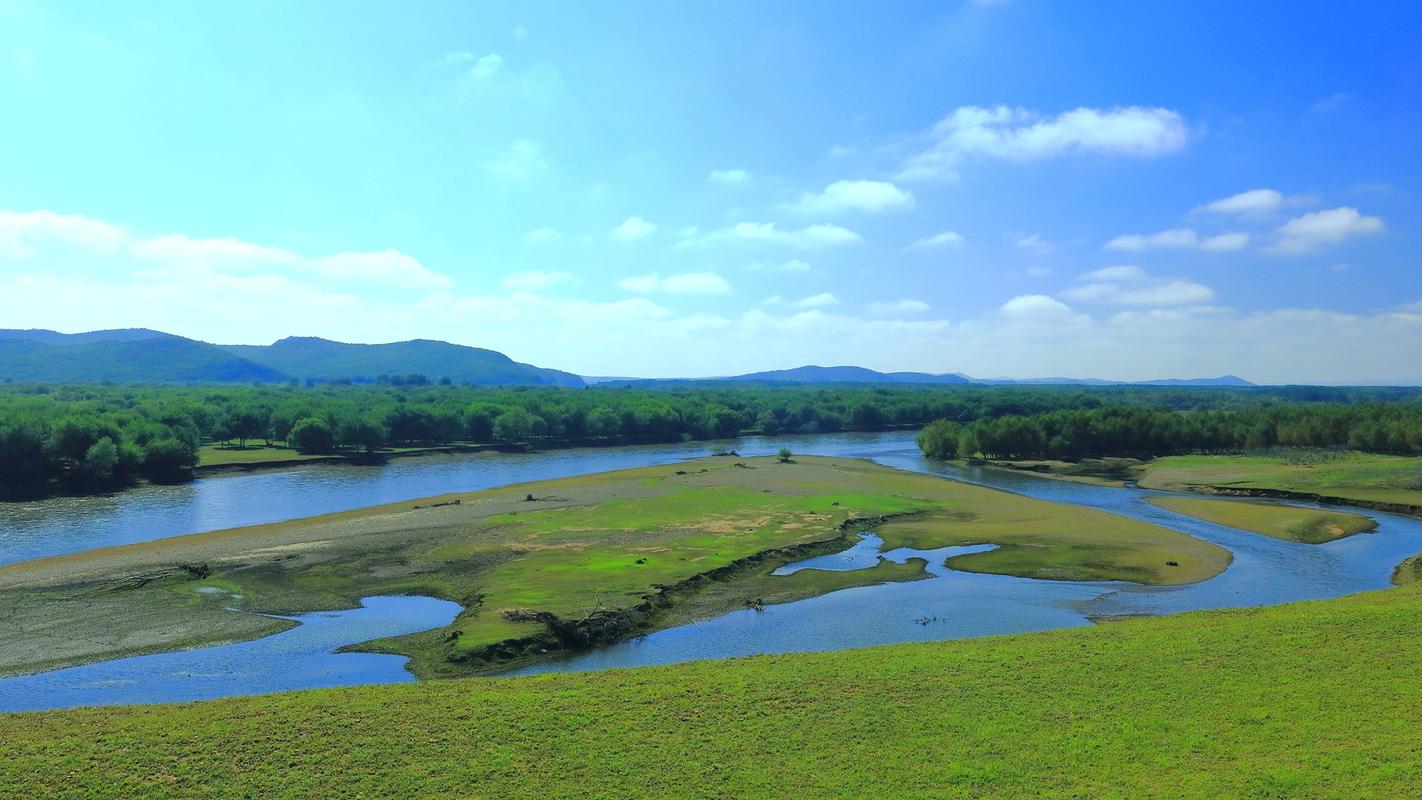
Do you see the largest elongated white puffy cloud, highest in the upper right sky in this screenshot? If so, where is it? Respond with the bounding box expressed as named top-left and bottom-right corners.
top-left (899, 105), bottom-right (1189, 180)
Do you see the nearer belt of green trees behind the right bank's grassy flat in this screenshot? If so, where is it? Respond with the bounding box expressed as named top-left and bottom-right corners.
top-left (919, 399), bottom-right (1422, 459)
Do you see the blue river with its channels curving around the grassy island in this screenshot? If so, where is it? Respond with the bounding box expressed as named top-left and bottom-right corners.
top-left (0, 432), bottom-right (1422, 710)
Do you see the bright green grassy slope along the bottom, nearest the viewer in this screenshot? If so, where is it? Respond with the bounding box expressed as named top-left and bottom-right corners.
top-left (0, 585), bottom-right (1422, 799)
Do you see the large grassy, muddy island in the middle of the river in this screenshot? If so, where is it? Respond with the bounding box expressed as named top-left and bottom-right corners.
top-left (0, 458), bottom-right (1230, 676)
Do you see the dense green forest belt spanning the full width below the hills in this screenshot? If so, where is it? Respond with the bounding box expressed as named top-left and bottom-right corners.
top-left (0, 381), bottom-right (1422, 493)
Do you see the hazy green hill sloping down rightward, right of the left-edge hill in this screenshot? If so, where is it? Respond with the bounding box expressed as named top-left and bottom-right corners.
top-left (223, 337), bottom-right (583, 387)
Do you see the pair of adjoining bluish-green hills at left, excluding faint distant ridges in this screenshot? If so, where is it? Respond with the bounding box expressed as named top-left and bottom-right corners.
top-left (0, 328), bottom-right (584, 387)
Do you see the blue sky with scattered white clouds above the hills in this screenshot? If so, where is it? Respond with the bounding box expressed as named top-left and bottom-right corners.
top-left (0, 0), bottom-right (1422, 382)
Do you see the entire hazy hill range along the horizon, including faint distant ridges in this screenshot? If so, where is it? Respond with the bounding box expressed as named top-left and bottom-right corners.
top-left (0, 328), bottom-right (1254, 388)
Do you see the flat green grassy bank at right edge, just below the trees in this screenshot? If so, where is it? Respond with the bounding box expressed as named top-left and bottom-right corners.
top-left (1139, 453), bottom-right (1422, 506)
